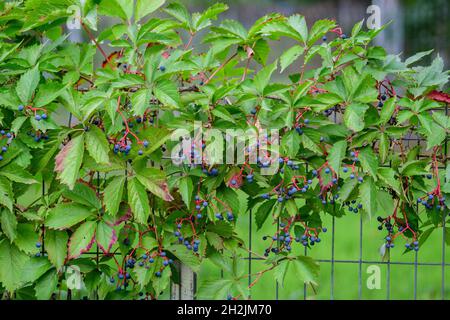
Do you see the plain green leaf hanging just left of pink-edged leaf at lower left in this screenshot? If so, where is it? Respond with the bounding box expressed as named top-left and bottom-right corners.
top-left (45, 229), bottom-right (69, 270)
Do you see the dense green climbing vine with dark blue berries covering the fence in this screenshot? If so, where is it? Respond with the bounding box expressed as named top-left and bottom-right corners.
top-left (0, 0), bottom-right (450, 299)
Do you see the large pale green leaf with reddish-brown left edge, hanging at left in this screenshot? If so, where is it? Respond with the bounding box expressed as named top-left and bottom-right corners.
top-left (55, 135), bottom-right (84, 189)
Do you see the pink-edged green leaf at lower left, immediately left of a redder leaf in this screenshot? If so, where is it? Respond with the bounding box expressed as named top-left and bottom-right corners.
top-left (68, 221), bottom-right (97, 259)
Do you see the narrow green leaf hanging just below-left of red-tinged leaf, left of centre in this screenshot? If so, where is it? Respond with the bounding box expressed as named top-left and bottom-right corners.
top-left (128, 177), bottom-right (150, 224)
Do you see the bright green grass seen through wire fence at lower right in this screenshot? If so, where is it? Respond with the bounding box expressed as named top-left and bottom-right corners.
top-left (198, 208), bottom-right (450, 300)
